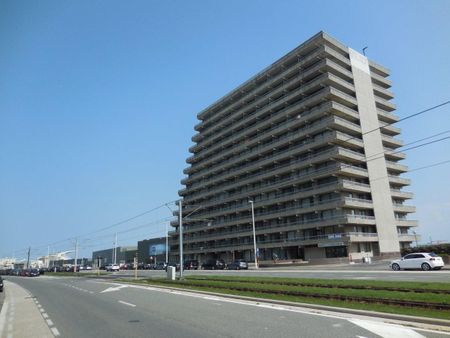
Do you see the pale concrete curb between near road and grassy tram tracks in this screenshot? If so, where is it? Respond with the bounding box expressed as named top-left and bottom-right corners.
top-left (117, 281), bottom-right (450, 333)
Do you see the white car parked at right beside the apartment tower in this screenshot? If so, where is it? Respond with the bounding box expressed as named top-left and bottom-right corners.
top-left (389, 252), bottom-right (444, 271)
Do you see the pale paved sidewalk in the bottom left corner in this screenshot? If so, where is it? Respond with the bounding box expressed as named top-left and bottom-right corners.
top-left (0, 281), bottom-right (54, 338)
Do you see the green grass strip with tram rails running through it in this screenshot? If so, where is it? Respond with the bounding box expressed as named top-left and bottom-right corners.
top-left (121, 276), bottom-right (450, 319)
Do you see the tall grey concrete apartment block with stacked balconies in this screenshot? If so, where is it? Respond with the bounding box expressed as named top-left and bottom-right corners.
top-left (171, 32), bottom-right (417, 261)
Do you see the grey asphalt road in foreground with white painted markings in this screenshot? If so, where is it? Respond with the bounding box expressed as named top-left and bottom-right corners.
top-left (2, 276), bottom-right (448, 338)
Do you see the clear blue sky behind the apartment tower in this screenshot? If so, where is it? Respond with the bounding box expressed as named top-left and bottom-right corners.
top-left (0, 0), bottom-right (450, 257)
